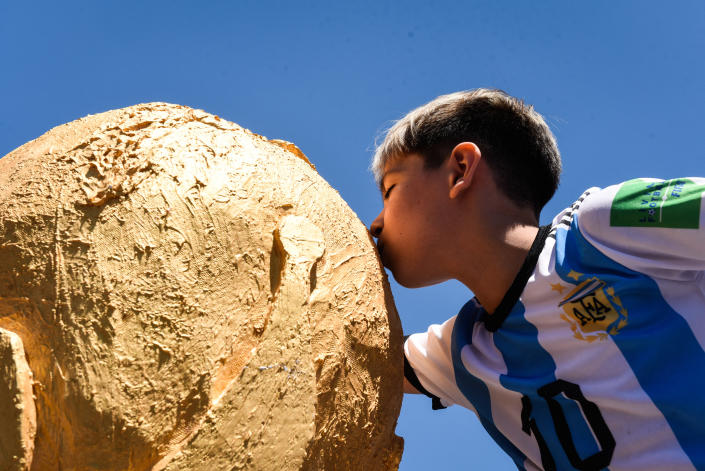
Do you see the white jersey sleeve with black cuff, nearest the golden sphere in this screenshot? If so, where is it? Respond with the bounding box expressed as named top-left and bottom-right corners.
top-left (404, 317), bottom-right (457, 409)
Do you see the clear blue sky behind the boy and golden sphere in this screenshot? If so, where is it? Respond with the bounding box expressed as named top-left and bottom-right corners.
top-left (0, 0), bottom-right (705, 471)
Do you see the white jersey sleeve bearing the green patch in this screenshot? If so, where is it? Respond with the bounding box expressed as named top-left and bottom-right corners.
top-left (574, 177), bottom-right (705, 280)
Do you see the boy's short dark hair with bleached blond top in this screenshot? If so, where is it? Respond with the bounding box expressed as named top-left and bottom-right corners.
top-left (372, 88), bottom-right (561, 218)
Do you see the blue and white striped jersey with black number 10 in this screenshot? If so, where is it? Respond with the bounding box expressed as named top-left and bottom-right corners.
top-left (404, 178), bottom-right (705, 471)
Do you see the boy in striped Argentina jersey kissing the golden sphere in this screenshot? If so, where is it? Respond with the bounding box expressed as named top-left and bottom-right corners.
top-left (371, 89), bottom-right (705, 470)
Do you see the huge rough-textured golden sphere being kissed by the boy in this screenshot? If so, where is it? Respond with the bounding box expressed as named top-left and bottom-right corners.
top-left (0, 103), bottom-right (402, 471)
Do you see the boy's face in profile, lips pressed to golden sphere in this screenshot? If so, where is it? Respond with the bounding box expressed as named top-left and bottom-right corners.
top-left (370, 154), bottom-right (452, 288)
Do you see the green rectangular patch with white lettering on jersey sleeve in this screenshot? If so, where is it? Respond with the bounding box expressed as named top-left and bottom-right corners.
top-left (610, 178), bottom-right (705, 229)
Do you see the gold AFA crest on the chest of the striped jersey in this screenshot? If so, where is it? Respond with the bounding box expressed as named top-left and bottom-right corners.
top-left (558, 277), bottom-right (628, 342)
